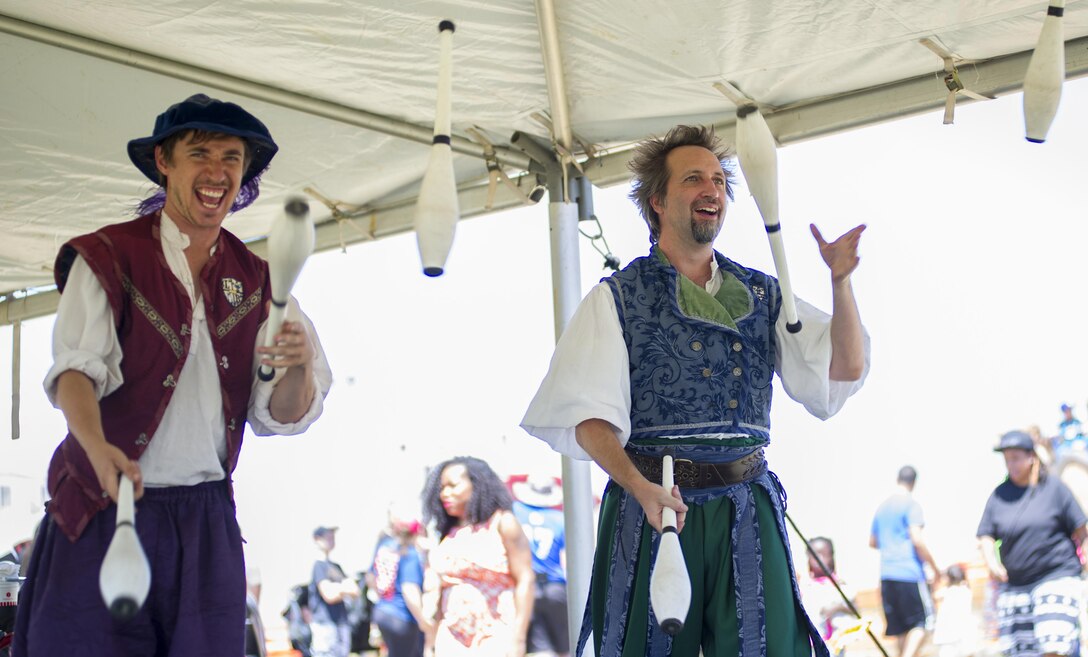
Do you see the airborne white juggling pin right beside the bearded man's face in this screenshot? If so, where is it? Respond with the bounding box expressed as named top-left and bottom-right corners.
top-left (737, 106), bottom-right (801, 333)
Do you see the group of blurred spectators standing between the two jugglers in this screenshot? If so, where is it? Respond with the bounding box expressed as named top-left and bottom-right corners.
top-left (284, 457), bottom-right (569, 657)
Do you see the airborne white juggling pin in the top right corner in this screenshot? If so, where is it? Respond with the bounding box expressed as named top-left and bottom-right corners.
top-left (1024, 0), bottom-right (1065, 144)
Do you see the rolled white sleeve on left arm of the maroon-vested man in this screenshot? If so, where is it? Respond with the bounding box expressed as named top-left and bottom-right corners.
top-left (42, 256), bottom-right (124, 406)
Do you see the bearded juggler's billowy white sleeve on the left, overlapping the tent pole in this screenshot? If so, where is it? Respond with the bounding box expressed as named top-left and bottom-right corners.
top-left (521, 283), bottom-right (631, 461)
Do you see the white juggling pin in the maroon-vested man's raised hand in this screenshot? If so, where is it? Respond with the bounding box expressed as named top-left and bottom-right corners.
top-left (257, 197), bottom-right (314, 381)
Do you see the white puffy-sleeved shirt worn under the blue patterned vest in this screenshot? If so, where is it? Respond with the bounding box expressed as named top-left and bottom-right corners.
top-left (521, 268), bottom-right (869, 460)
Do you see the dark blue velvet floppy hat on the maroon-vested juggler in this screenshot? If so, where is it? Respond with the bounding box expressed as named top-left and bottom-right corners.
top-left (128, 94), bottom-right (280, 186)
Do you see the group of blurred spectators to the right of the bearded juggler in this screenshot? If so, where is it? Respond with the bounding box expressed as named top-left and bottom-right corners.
top-left (802, 404), bottom-right (1088, 657)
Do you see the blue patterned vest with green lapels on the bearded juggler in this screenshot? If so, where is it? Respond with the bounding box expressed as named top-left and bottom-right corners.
top-left (604, 246), bottom-right (781, 443)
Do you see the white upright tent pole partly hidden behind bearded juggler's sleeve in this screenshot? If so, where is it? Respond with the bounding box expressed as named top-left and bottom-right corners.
top-left (548, 194), bottom-right (594, 649)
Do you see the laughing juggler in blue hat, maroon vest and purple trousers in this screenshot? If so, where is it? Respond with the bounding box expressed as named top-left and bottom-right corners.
top-left (14, 95), bottom-right (331, 657)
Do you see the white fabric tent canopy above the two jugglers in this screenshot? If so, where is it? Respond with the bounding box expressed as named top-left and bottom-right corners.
top-left (0, 0), bottom-right (1088, 325)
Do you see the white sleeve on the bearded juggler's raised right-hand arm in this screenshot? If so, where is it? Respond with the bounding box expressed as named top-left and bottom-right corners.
top-left (775, 299), bottom-right (869, 420)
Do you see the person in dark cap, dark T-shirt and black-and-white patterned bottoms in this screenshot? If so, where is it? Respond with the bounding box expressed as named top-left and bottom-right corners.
top-left (977, 431), bottom-right (1088, 656)
